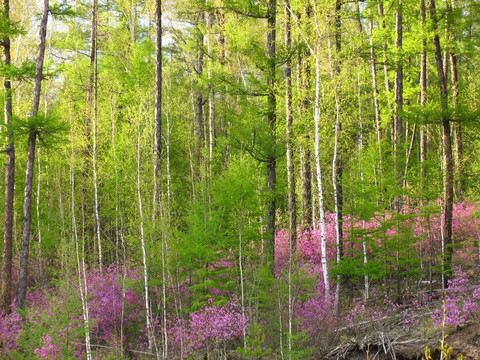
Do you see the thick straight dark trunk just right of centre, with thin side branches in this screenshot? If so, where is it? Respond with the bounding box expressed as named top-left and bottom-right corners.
top-left (265, 0), bottom-right (277, 271)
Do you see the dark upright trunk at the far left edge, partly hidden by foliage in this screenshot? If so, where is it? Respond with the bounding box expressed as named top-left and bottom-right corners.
top-left (0, 0), bottom-right (15, 313)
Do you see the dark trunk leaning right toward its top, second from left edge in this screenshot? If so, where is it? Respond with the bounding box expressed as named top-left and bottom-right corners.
top-left (16, 0), bottom-right (49, 309)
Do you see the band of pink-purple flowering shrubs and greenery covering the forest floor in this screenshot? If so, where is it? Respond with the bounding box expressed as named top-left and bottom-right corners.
top-left (0, 203), bottom-right (480, 359)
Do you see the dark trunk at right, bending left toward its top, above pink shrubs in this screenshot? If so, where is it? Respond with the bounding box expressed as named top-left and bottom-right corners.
top-left (429, 0), bottom-right (453, 287)
